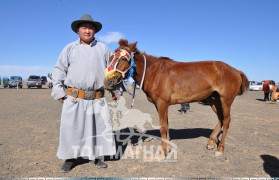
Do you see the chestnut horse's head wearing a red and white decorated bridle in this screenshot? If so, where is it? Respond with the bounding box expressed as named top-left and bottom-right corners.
top-left (104, 39), bottom-right (137, 91)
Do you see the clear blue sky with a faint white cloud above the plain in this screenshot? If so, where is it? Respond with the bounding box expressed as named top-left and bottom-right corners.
top-left (0, 0), bottom-right (279, 82)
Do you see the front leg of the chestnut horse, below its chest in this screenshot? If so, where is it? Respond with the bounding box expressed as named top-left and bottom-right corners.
top-left (156, 100), bottom-right (170, 156)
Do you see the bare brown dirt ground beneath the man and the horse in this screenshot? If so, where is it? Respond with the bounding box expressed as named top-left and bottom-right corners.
top-left (0, 86), bottom-right (279, 178)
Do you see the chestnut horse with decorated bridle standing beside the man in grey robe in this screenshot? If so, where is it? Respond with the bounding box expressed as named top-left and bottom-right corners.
top-left (105, 40), bottom-right (249, 156)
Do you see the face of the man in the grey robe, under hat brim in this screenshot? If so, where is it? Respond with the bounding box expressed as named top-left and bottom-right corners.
top-left (77, 23), bottom-right (95, 44)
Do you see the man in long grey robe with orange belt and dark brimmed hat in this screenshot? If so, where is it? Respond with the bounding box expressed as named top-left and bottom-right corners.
top-left (51, 14), bottom-right (116, 172)
